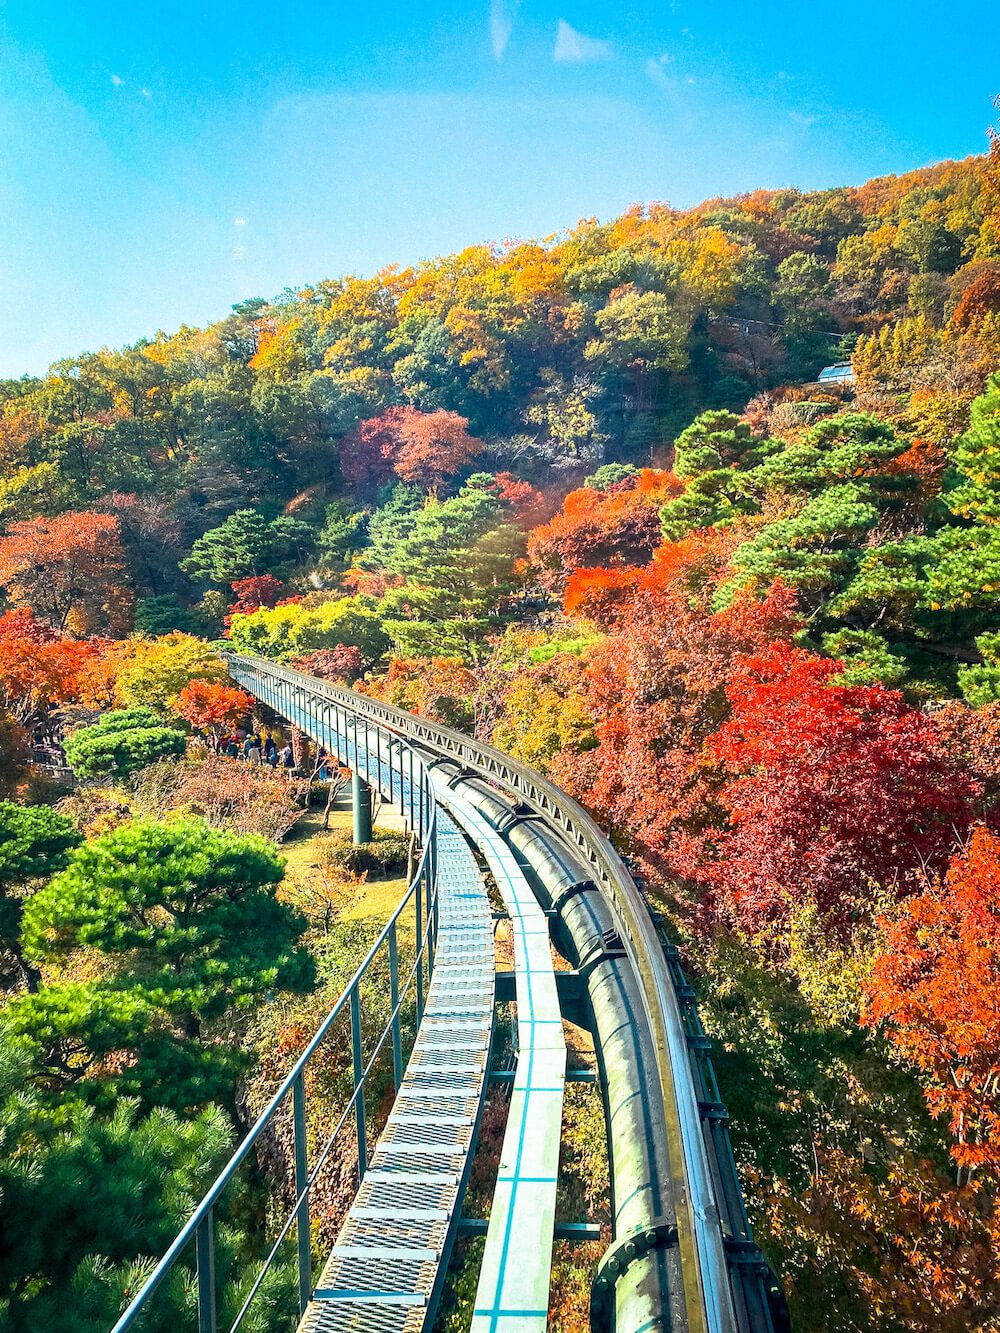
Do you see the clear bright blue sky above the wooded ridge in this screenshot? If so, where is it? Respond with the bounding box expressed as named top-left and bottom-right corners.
top-left (0, 0), bottom-right (1000, 375)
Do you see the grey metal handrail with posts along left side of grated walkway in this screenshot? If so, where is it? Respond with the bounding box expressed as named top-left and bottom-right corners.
top-left (111, 698), bottom-right (437, 1333)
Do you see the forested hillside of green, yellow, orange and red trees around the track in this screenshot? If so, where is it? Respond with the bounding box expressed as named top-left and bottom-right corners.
top-left (0, 140), bottom-right (1000, 1333)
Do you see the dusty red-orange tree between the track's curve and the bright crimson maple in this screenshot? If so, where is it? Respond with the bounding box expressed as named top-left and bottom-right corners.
top-left (549, 535), bottom-right (799, 878)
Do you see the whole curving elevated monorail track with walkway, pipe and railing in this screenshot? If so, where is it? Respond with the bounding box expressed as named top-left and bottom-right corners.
top-left (113, 655), bottom-right (787, 1333)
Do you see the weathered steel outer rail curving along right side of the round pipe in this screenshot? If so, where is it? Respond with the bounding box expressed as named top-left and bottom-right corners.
top-left (224, 653), bottom-right (737, 1333)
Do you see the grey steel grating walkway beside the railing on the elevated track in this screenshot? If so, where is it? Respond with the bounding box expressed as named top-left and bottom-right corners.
top-left (299, 728), bottom-right (495, 1333)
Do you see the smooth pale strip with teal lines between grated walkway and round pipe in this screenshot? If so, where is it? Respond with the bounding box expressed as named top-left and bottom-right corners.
top-left (437, 789), bottom-right (567, 1333)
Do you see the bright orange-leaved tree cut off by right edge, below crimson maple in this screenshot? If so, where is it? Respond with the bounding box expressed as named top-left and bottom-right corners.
top-left (867, 828), bottom-right (1000, 1176)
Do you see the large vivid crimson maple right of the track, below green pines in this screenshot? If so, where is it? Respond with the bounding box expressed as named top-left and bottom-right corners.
top-left (692, 643), bottom-right (975, 926)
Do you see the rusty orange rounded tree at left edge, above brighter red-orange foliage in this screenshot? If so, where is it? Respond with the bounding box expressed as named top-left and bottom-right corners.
top-left (0, 512), bottom-right (131, 636)
